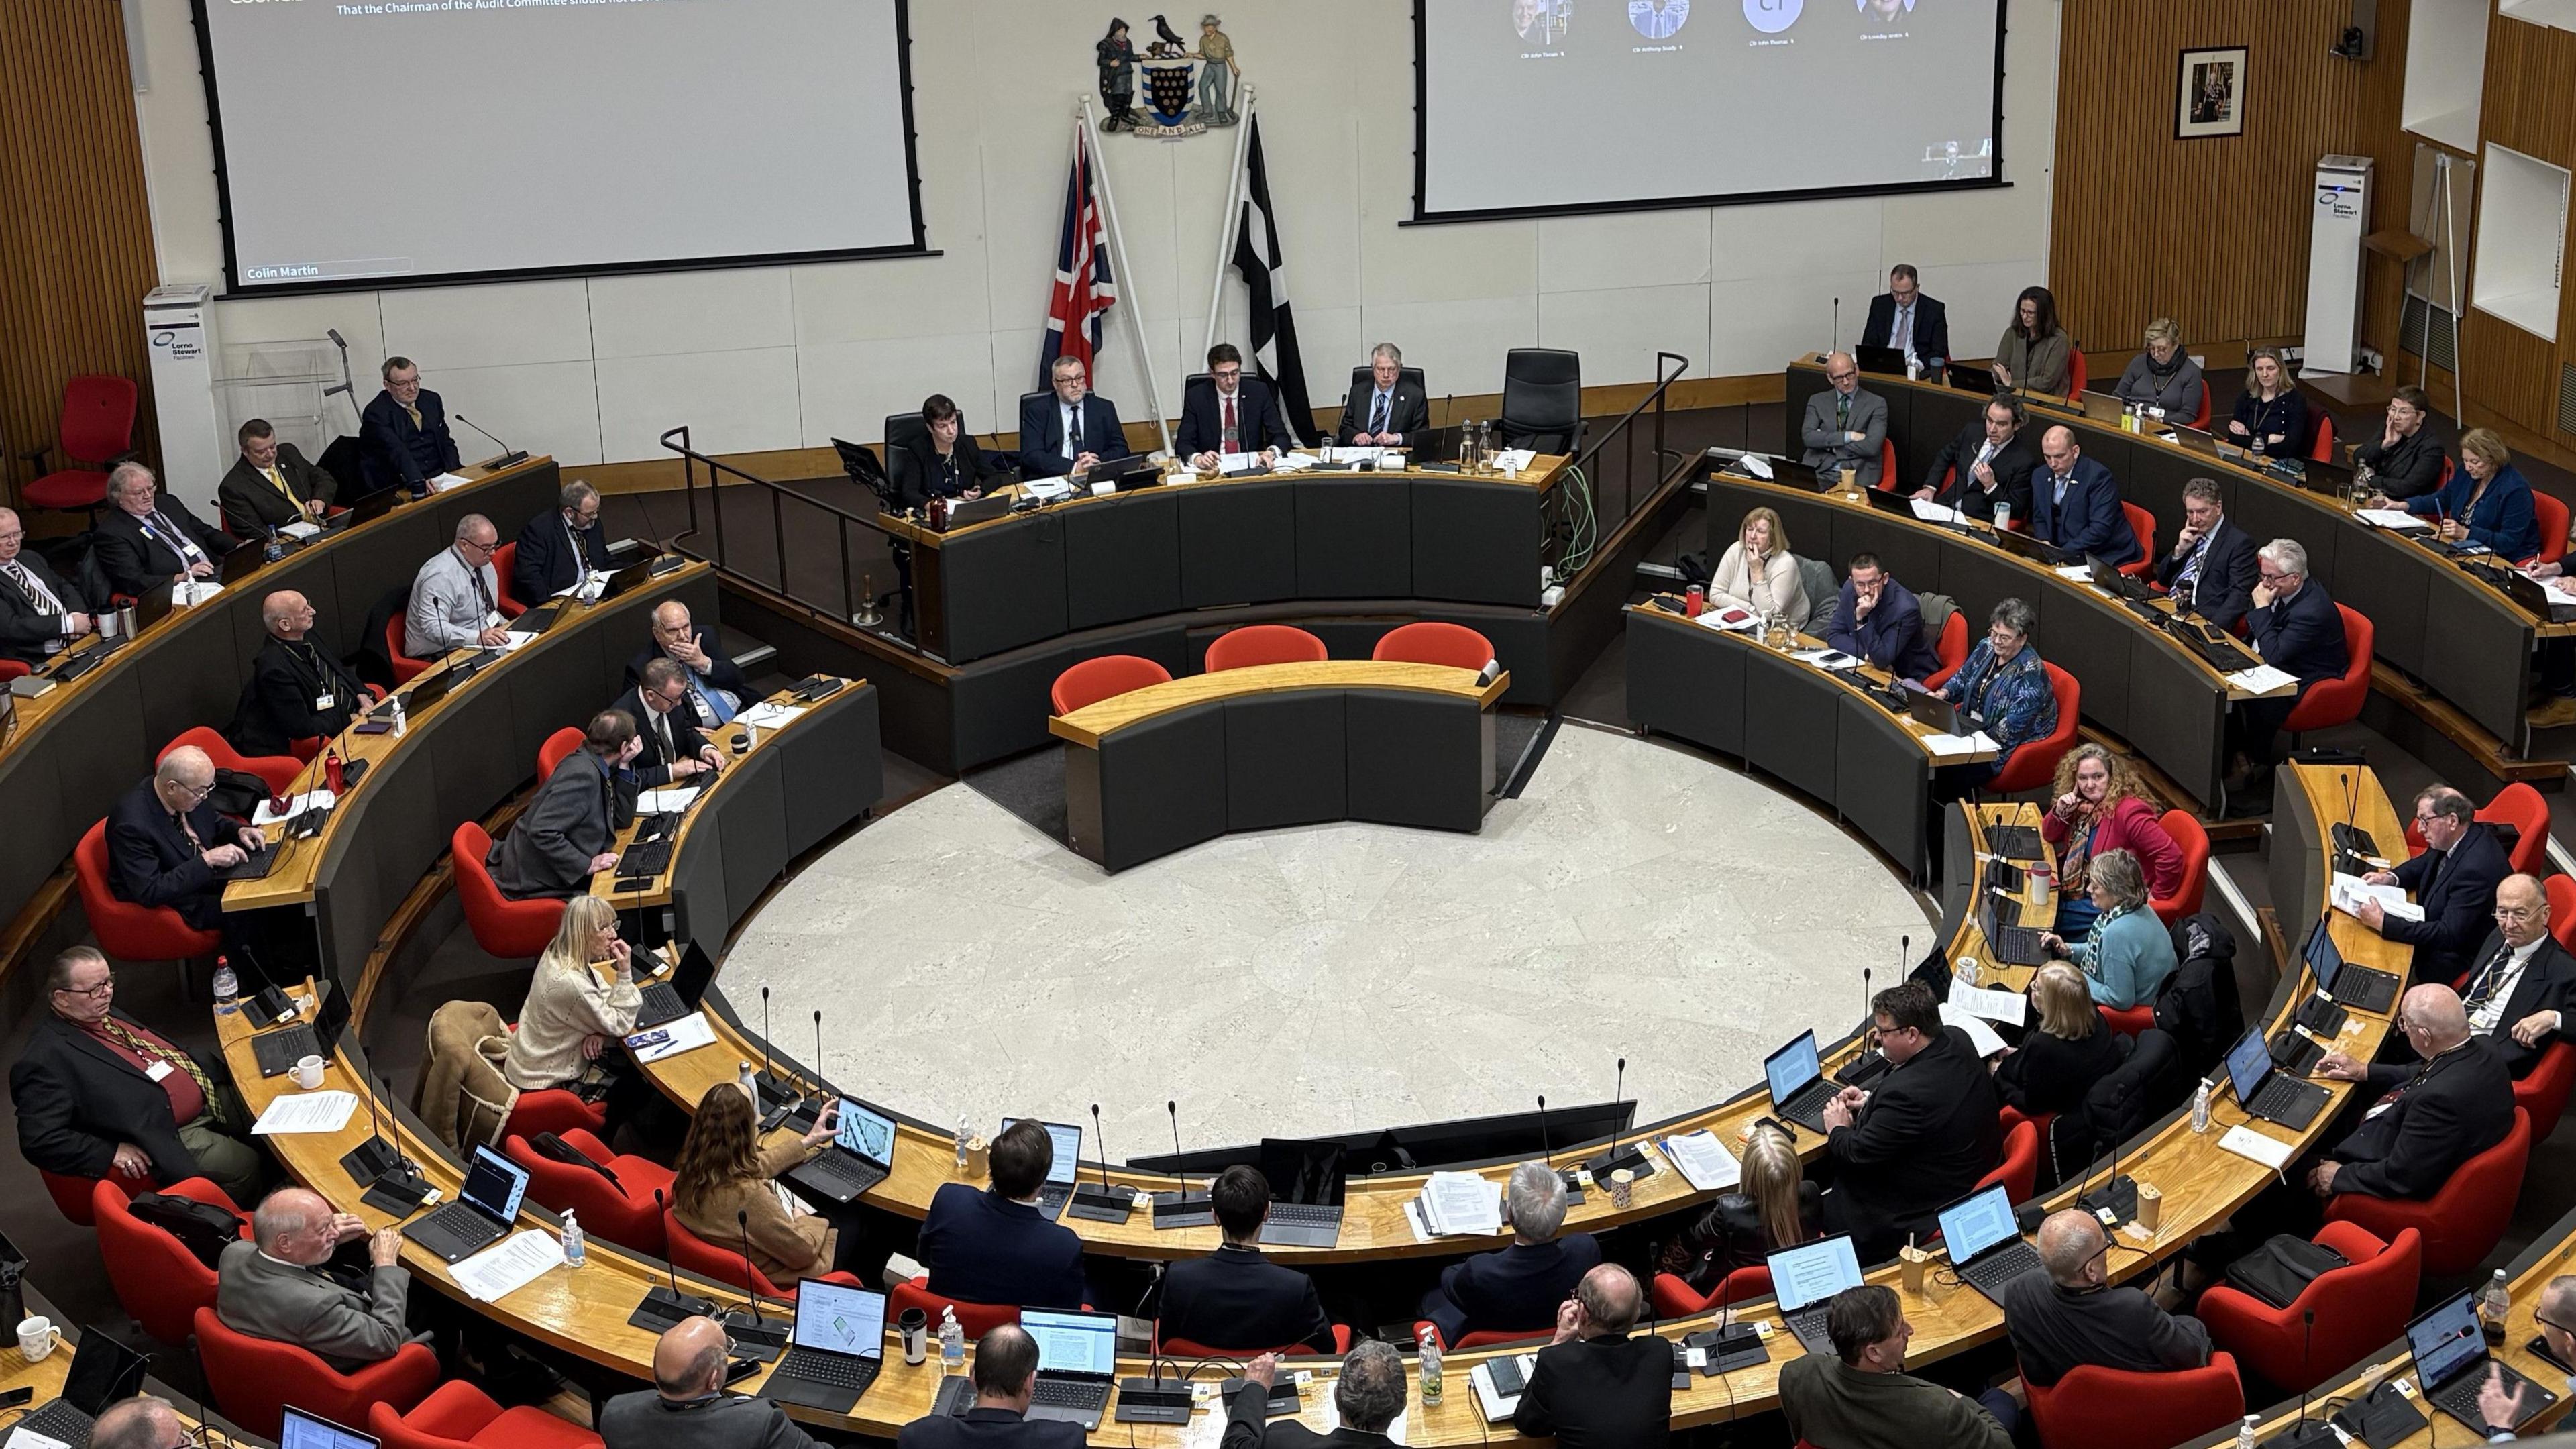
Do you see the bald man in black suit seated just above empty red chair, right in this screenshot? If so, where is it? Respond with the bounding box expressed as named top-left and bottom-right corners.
top-left (2306, 985), bottom-right (2514, 1201)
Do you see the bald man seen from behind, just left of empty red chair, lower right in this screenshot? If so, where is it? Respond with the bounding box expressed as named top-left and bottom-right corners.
top-left (2004, 1207), bottom-right (2210, 1387)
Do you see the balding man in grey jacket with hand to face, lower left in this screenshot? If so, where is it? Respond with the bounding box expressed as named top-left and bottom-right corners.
top-left (214, 1189), bottom-right (412, 1375)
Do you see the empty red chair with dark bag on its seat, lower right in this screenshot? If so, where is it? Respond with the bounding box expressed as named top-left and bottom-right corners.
top-left (2195, 1222), bottom-right (2424, 1392)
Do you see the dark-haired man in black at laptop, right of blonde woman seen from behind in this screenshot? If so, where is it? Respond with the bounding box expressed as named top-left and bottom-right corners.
top-left (1824, 982), bottom-right (2004, 1263)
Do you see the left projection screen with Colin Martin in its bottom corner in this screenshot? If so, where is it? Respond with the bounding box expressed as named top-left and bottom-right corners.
top-left (196, 0), bottom-right (925, 294)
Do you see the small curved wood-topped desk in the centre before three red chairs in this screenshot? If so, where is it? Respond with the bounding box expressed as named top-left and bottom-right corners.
top-left (1046, 660), bottom-right (1512, 871)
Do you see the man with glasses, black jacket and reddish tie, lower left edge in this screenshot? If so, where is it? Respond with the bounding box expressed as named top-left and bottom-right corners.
top-left (8, 947), bottom-right (270, 1201)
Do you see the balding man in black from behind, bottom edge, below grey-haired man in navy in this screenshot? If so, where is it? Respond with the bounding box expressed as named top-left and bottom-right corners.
top-left (1512, 1263), bottom-right (1672, 1449)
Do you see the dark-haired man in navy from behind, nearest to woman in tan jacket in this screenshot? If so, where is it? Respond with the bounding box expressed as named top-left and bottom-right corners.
top-left (920, 1116), bottom-right (1087, 1304)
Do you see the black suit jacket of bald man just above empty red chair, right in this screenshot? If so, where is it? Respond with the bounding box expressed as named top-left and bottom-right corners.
top-left (2326, 1036), bottom-right (2514, 1201)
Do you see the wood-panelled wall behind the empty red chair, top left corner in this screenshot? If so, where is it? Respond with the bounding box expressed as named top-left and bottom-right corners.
top-left (0, 0), bottom-right (160, 500)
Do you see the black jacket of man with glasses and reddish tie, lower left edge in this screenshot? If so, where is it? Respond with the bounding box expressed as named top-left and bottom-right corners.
top-left (8, 1008), bottom-right (232, 1186)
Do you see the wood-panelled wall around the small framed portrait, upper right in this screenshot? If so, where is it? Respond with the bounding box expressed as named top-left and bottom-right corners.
top-left (2050, 0), bottom-right (2411, 361)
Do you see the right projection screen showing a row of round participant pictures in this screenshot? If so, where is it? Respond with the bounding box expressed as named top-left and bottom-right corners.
top-left (1414, 0), bottom-right (2004, 222)
